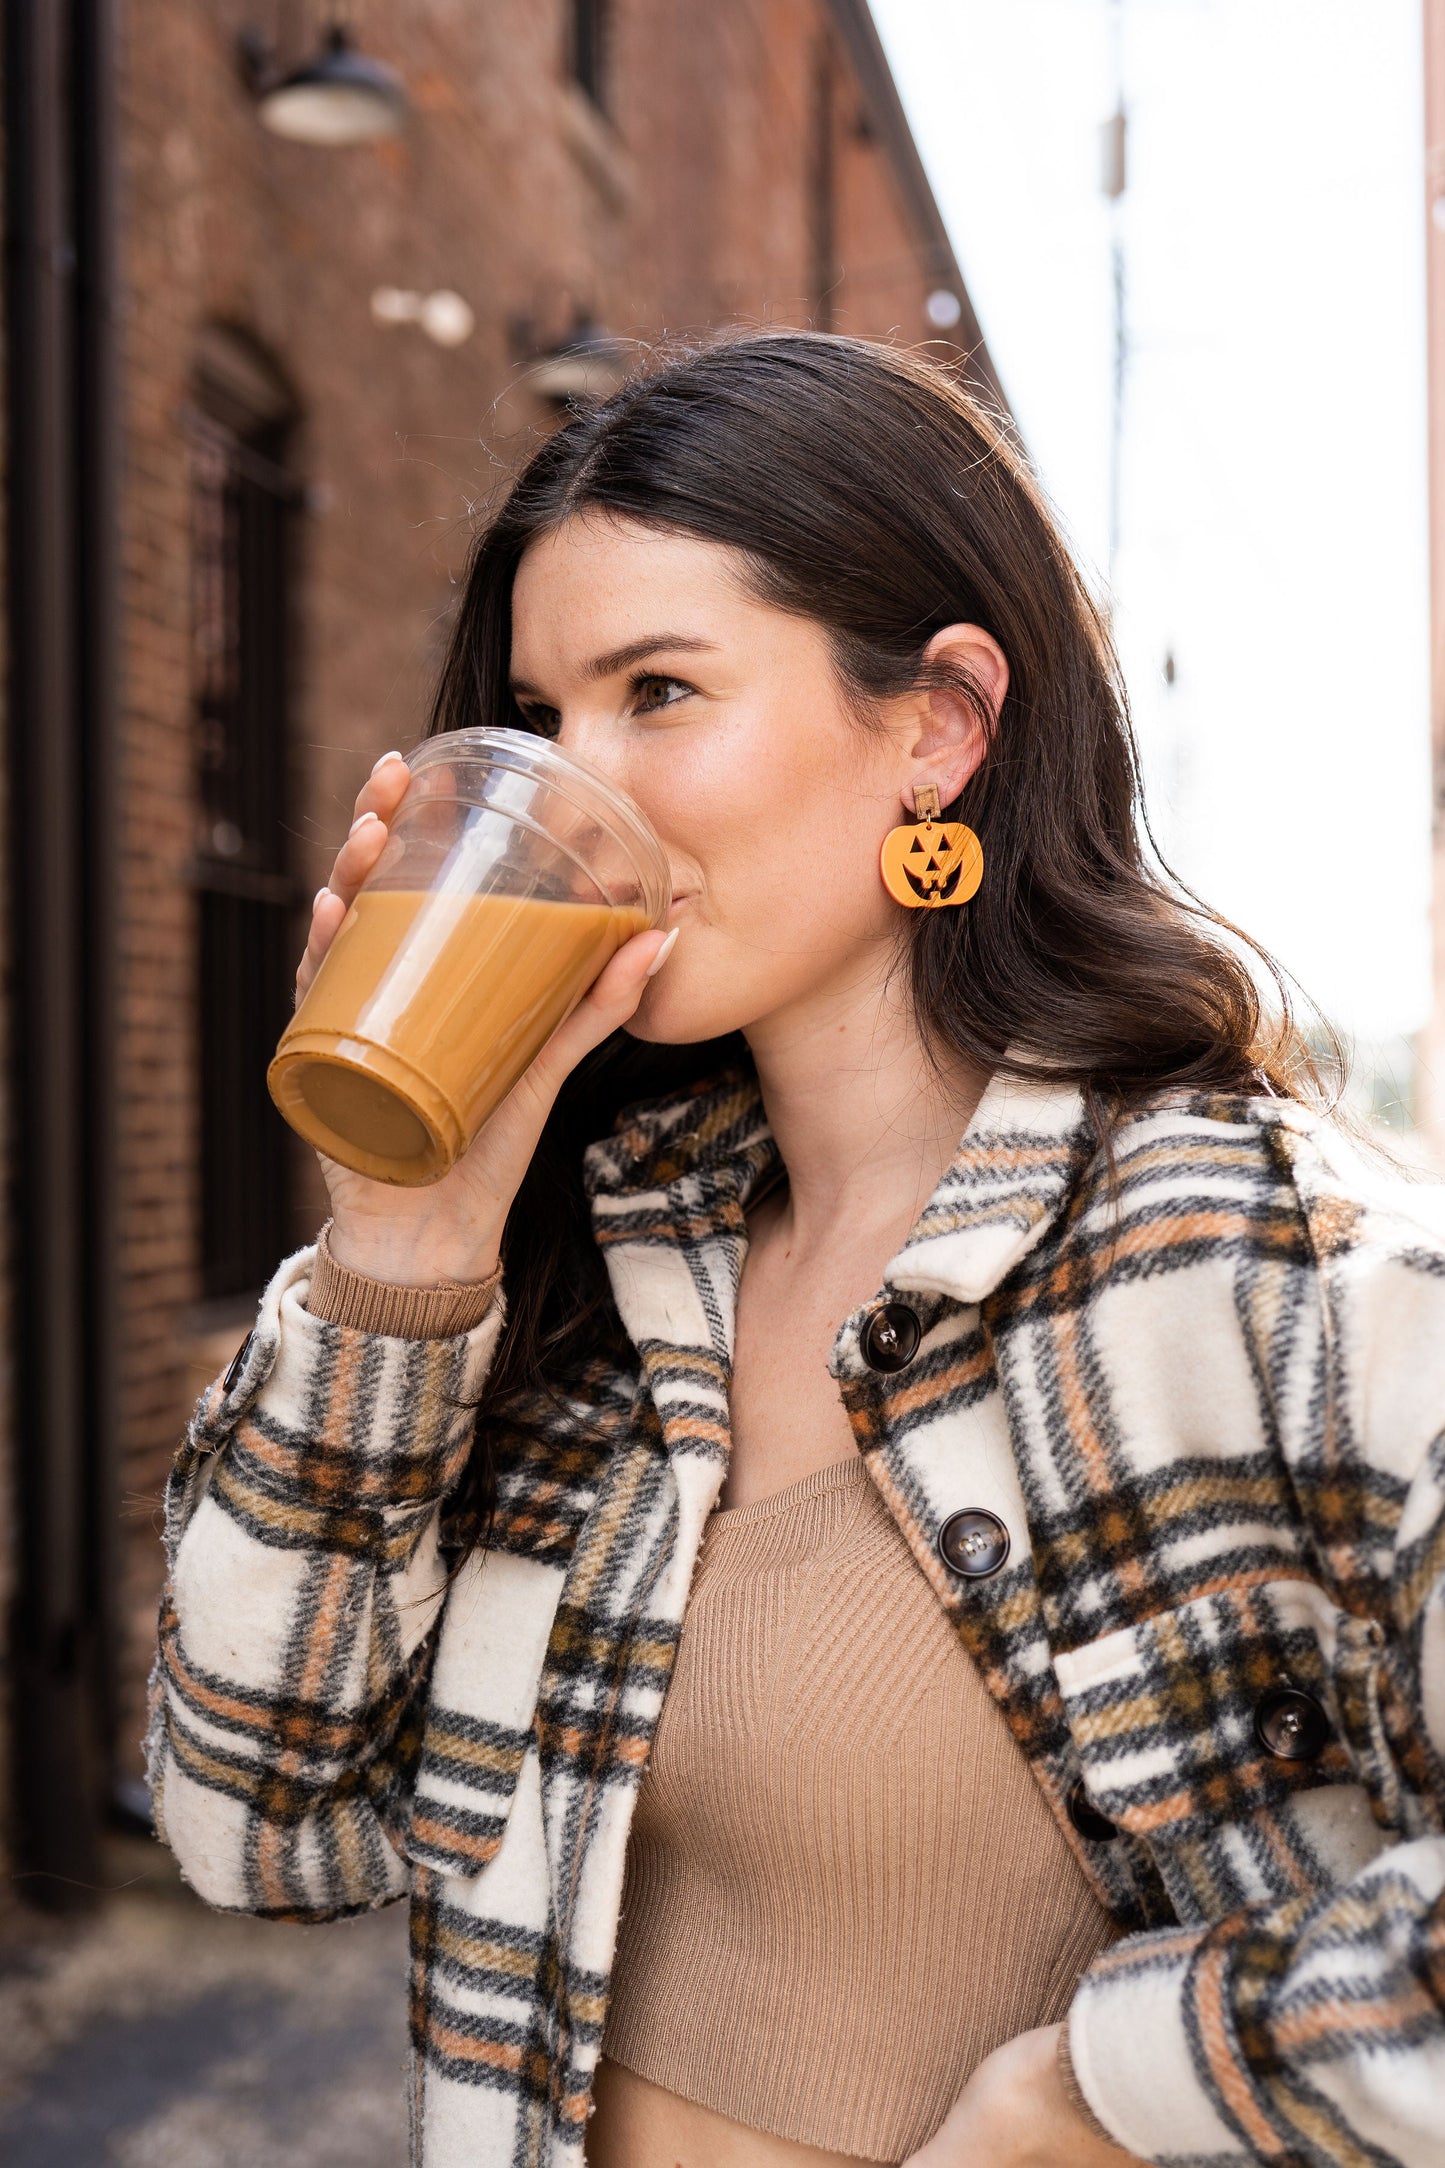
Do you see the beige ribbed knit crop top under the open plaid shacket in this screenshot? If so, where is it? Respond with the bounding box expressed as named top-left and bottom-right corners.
top-left (602, 1459), bottom-right (1114, 2161)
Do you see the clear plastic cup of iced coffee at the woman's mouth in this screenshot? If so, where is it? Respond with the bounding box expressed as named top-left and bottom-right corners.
top-left (266, 728), bottom-right (672, 1184)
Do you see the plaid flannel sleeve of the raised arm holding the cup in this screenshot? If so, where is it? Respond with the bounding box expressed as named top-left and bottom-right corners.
top-left (145, 1249), bottom-right (503, 1919)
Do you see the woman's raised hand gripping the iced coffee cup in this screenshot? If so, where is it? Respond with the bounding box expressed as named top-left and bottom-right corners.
top-left (297, 752), bottom-right (672, 1288)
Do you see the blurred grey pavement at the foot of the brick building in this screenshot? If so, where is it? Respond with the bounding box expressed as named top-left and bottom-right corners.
top-left (0, 1838), bottom-right (407, 2168)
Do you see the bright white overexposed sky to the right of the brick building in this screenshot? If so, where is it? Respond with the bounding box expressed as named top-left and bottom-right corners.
top-left (875, 0), bottom-right (1430, 1051)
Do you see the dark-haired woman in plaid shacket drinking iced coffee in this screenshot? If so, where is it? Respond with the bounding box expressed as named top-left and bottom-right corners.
top-left (149, 334), bottom-right (1445, 2168)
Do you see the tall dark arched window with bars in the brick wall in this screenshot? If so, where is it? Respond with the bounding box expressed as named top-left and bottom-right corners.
top-left (191, 332), bottom-right (301, 1301)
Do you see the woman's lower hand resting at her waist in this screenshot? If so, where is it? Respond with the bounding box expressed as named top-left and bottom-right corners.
top-left (903, 2025), bottom-right (1140, 2168)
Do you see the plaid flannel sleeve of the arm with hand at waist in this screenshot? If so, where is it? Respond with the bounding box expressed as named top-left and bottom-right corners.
top-left (1068, 1145), bottom-right (1445, 2168)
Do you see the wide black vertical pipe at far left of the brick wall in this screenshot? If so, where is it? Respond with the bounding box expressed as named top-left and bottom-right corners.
top-left (4, 0), bottom-right (102, 1906)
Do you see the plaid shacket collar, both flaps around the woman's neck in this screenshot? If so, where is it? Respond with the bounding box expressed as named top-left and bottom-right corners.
top-left (583, 1071), bottom-right (1092, 1309)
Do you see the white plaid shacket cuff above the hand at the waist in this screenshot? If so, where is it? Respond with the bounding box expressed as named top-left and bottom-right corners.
top-left (1059, 1927), bottom-right (1252, 2168)
